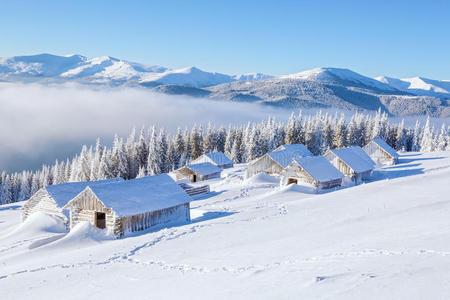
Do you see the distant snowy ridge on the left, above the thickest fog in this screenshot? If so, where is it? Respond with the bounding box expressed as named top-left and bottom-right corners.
top-left (0, 54), bottom-right (271, 88)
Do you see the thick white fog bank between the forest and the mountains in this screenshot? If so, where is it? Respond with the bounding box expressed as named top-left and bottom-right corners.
top-left (0, 83), bottom-right (290, 171)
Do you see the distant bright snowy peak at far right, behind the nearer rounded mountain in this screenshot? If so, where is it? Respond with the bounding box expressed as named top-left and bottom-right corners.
top-left (375, 76), bottom-right (450, 99)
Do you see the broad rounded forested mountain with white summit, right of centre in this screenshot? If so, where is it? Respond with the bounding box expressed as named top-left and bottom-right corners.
top-left (207, 74), bottom-right (450, 117)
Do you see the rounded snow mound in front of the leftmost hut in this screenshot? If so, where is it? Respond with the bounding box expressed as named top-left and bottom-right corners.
top-left (8, 212), bottom-right (67, 236)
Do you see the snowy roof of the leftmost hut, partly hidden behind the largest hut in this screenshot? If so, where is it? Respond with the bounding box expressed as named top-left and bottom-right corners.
top-left (45, 178), bottom-right (124, 207)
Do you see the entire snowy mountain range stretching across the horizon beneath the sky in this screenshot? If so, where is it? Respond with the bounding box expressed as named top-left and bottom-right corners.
top-left (0, 54), bottom-right (450, 117)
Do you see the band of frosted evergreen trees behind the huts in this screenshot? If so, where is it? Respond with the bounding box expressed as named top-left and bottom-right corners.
top-left (0, 111), bottom-right (450, 204)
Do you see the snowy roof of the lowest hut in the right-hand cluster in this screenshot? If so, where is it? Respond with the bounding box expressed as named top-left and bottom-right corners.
top-left (292, 156), bottom-right (344, 182)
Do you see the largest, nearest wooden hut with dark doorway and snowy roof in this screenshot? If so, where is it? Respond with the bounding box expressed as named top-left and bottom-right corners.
top-left (64, 174), bottom-right (192, 237)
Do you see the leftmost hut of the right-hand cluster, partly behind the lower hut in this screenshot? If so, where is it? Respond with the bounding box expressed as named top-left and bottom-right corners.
top-left (245, 144), bottom-right (313, 178)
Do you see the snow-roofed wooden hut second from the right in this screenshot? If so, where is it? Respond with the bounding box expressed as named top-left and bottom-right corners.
top-left (324, 146), bottom-right (375, 183)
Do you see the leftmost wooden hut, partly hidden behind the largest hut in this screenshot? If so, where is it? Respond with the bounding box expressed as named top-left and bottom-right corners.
top-left (22, 178), bottom-right (124, 224)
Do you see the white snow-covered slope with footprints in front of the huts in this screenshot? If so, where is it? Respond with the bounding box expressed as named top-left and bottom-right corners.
top-left (0, 152), bottom-right (450, 299)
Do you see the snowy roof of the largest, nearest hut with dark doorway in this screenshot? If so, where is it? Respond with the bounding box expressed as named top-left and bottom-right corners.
top-left (76, 174), bottom-right (192, 217)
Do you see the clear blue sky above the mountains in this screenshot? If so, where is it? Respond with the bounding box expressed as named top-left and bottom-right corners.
top-left (0, 0), bottom-right (450, 80)
